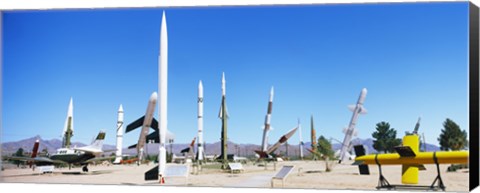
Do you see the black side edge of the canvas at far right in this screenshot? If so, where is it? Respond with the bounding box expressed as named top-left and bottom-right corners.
top-left (469, 2), bottom-right (480, 191)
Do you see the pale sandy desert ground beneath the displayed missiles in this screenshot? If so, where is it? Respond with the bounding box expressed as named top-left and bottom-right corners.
top-left (0, 161), bottom-right (469, 192)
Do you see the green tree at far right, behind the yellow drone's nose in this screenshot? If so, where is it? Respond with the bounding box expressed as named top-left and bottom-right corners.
top-left (437, 118), bottom-right (468, 151)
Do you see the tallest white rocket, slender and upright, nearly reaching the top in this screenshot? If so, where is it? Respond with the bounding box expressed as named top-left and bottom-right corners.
top-left (158, 11), bottom-right (168, 183)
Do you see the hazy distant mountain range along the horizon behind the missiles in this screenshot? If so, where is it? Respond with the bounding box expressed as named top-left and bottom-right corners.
top-left (1, 135), bottom-right (440, 157)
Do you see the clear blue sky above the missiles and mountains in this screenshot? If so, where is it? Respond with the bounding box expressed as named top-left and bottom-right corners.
top-left (2, 2), bottom-right (468, 147)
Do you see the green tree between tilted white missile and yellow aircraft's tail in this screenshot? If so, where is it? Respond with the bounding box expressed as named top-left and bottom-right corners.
top-left (372, 121), bottom-right (402, 153)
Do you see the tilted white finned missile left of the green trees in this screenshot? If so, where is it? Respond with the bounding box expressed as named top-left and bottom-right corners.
top-left (338, 88), bottom-right (367, 163)
